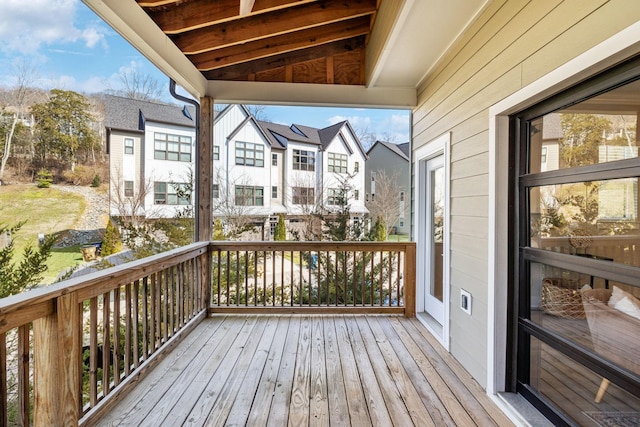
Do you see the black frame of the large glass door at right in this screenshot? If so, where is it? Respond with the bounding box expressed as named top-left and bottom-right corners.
top-left (506, 58), bottom-right (640, 425)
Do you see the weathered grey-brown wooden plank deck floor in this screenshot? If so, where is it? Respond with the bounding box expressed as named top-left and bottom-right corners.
top-left (90, 315), bottom-right (512, 426)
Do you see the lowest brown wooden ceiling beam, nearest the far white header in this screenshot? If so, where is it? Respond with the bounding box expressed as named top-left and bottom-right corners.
top-left (202, 36), bottom-right (365, 80)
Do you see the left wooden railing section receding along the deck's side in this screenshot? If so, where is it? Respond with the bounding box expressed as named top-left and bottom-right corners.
top-left (0, 242), bottom-right (210, 426)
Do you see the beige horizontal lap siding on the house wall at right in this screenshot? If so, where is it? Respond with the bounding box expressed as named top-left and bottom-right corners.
top-left (412, 0), bottom-right (640, 386)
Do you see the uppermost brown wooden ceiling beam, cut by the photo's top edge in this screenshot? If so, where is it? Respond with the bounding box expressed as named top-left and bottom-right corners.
top-left (144, 0), bottom-right (317, 34)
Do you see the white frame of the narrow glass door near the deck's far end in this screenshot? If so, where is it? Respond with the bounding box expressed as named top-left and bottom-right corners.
top-left (413, 133), bottom-right (451, 351)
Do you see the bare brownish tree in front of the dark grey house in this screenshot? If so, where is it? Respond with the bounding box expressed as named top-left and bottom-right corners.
top-left (366, 170), bottom-right (403, 239)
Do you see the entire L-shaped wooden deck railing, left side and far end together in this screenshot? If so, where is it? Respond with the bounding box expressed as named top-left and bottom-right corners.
top-left (0, 242), bottom-right (415, 427)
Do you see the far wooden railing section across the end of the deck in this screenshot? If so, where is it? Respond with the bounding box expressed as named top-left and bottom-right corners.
top-left (211, 242), bottom-right (415, 316)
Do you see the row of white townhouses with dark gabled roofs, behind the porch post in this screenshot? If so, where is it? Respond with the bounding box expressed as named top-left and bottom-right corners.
top-left (104, 100), bottom-right (367, 240)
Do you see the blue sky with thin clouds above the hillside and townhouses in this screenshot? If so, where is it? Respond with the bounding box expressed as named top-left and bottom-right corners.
top-left (0, 0), bottom-right (409, 143)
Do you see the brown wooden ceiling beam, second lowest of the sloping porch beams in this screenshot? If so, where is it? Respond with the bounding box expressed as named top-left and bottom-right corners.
top-left (189, 16), bottom-right (369, 71)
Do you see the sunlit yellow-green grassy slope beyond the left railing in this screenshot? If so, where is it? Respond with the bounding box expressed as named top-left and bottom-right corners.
top-left (0, 184), bottom-right (86, 283)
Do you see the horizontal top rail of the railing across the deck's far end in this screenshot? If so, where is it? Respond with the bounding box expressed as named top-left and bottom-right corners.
top-left (209, 240), bottom-right (416, 252)
